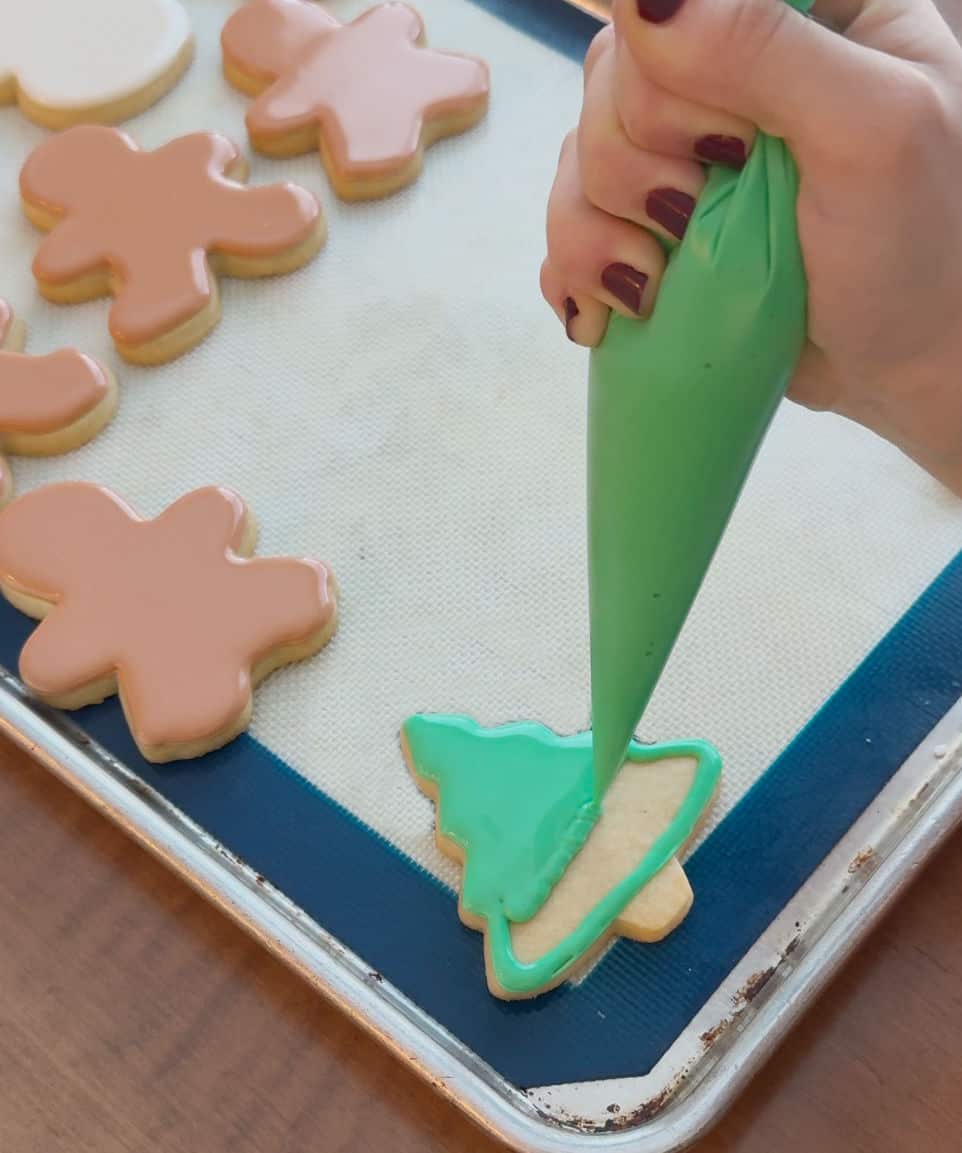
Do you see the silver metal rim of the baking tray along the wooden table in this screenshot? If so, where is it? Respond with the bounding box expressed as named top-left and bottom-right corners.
top-left (0, 670), bottom-right (962, 1153)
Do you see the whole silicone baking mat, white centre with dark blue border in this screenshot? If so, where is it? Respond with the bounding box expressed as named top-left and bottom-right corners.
top-left (0, 0), bottom-right (962, 1120)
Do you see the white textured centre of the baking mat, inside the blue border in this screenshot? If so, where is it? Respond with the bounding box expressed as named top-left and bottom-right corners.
top-left (0, 0), bottom-right (962, 881)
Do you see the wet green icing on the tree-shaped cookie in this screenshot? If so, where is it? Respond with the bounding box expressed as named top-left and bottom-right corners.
top-left (404, 715), bottom-right (721, 994)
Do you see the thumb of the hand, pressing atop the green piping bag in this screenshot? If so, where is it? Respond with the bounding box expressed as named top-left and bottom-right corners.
top-left (615, 0), bottom-right (909, 149)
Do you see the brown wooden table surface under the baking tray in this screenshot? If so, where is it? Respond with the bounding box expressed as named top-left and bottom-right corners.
top-left (0, 743), bottom-right (962, 1153)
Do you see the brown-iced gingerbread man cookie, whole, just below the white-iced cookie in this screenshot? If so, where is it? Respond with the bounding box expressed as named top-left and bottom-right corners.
top-left (20, 125), bottom-right (325, 364)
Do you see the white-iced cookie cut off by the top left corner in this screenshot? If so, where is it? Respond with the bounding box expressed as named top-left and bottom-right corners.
top-left (0, 0), bottom-right (193, 128)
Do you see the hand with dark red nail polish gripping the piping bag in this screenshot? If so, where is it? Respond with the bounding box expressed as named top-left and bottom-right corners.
top-left (541, 0), bottom-right (962, 495)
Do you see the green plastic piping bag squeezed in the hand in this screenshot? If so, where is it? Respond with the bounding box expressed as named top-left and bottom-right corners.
top-left (587, 2), bottom-right (807, 799)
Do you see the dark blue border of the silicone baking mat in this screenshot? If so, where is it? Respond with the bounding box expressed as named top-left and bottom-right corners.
top-left (0, 0), bottom-right (962, 1087)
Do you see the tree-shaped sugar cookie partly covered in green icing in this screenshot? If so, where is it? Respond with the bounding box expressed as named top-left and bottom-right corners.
top-left (401, 716), bottom-right (721, 1000)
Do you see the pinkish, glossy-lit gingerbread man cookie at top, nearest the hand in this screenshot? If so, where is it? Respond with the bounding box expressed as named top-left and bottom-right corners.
top-left (220, 0), bottom-right (488, 199)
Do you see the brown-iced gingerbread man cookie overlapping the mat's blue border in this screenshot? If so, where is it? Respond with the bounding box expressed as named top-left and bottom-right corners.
top-left (0, 483), bottom-right (337, 762)
